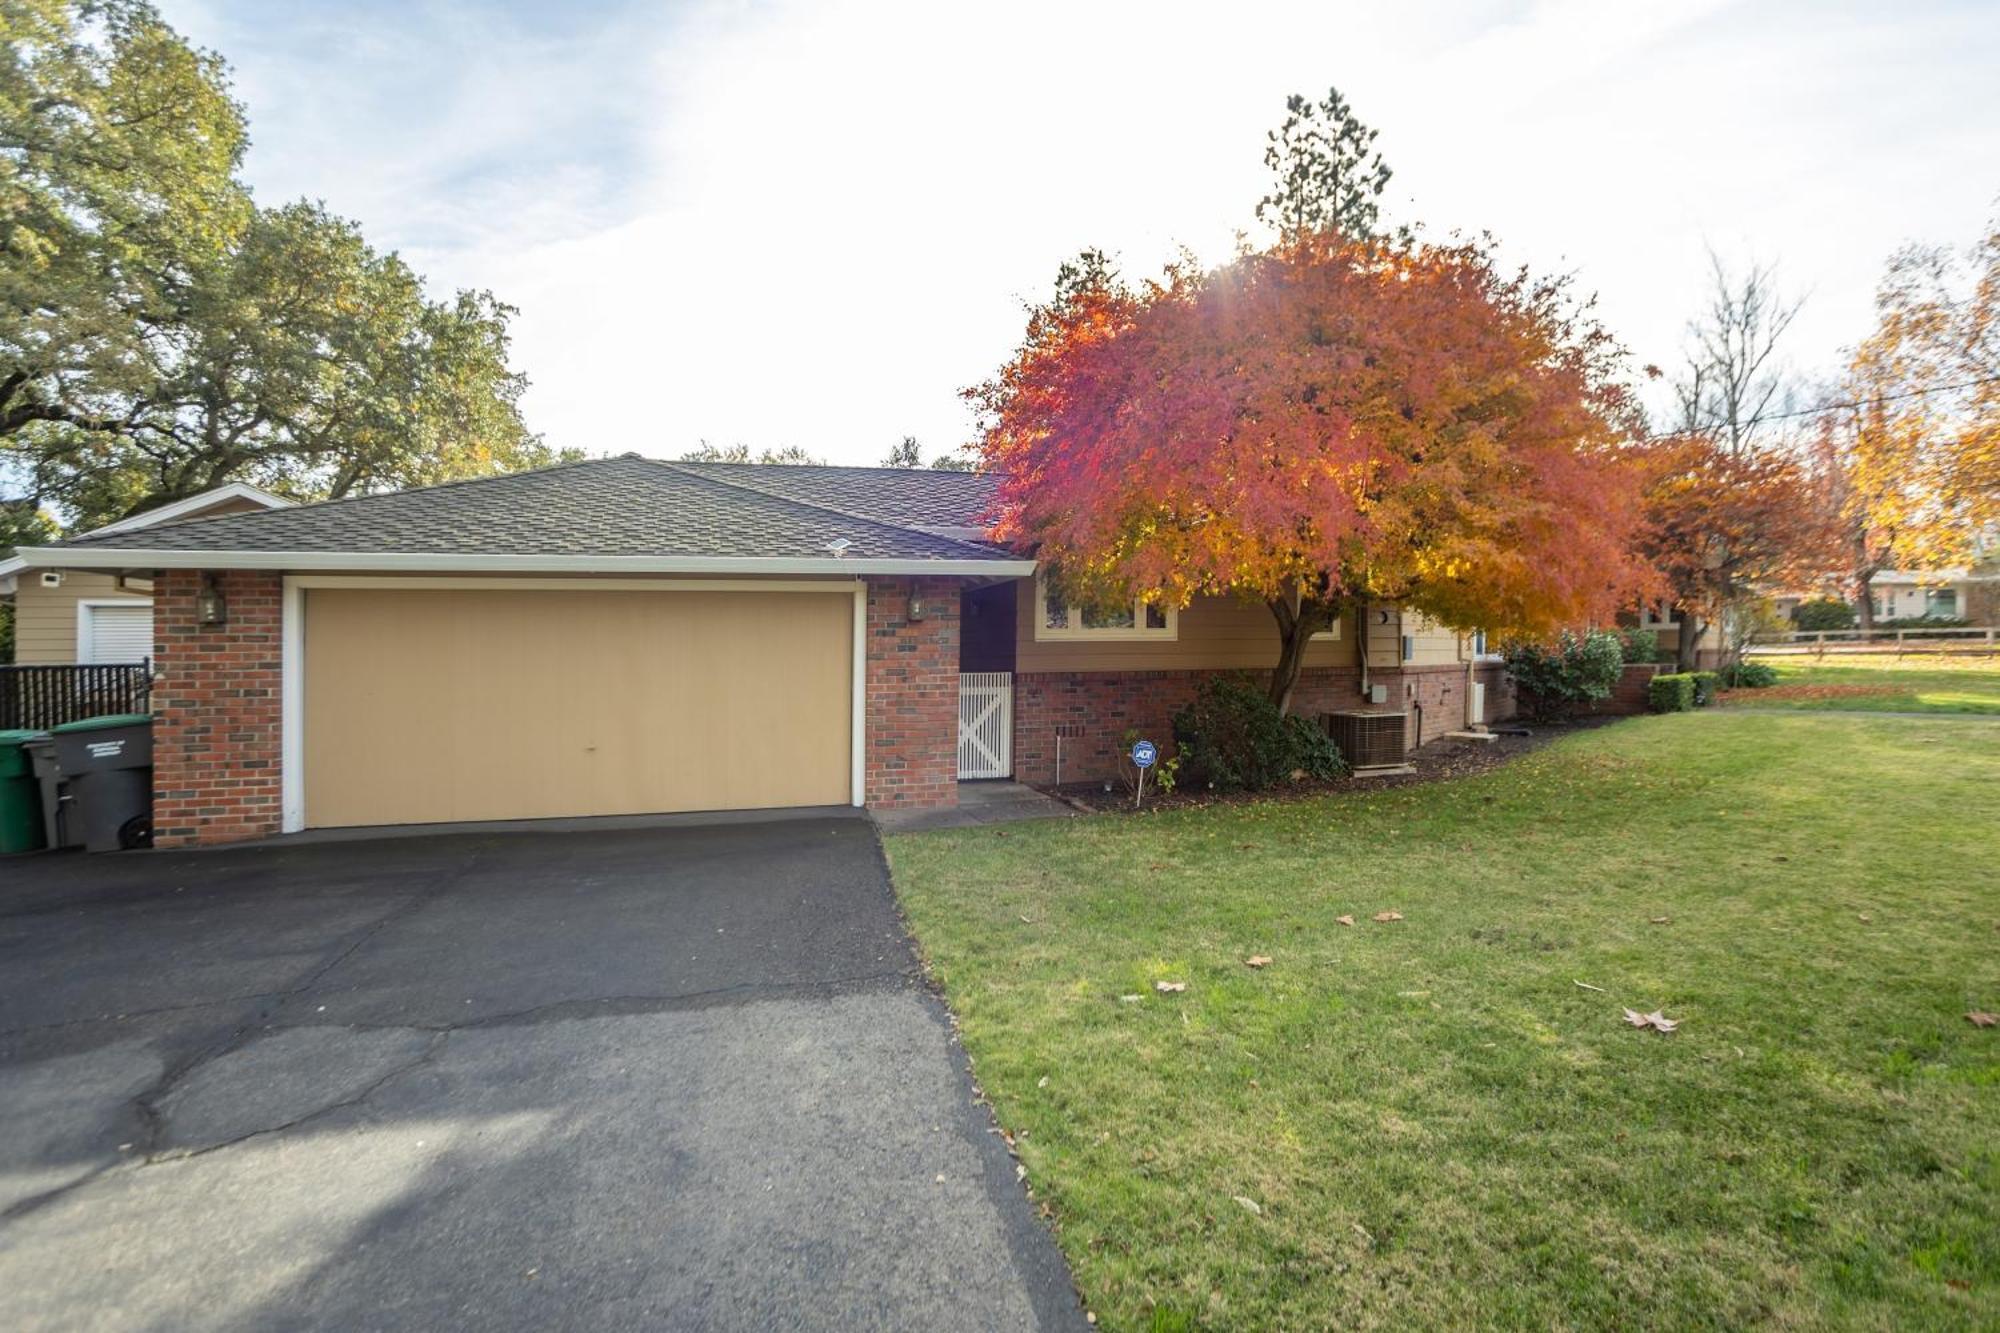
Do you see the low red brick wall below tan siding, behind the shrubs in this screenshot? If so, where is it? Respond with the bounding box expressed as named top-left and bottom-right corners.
top-left (1014, 664), bottom-right (1514, 783)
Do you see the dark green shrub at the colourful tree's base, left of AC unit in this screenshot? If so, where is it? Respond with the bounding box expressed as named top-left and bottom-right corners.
top-left (1174, 677), bottom-right (1348, 791)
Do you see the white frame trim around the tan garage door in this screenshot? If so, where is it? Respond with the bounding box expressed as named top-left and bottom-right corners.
top-left (278, 574), bottom-right (868, 833)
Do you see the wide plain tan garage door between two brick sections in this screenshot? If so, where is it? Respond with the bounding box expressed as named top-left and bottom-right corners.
top-left (304, 588), bottom-right (854, 829)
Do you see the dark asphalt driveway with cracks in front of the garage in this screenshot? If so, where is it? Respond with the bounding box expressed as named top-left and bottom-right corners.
top-left (0, 819), bottom-right (1082, 1329)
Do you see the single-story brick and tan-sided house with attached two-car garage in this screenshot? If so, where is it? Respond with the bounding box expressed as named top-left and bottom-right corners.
top-left (7, 454), bottom-right (1510, 847)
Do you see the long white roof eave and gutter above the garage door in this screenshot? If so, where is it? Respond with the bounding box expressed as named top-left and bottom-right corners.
top-left (14, 546), bottom-right (1034, 578)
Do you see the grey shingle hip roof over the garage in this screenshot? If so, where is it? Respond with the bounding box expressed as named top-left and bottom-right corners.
top-left (66, 454), bottom-right (1014, 560)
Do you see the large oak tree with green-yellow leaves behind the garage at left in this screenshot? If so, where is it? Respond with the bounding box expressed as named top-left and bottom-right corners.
top-left (0, 0), bottom-right (556, 528)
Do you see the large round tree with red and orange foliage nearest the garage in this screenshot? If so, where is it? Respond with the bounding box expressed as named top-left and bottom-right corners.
top-left (968, 236), bottom-right (1650, 703)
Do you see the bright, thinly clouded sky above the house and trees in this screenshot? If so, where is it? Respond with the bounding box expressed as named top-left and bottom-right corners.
top-left (162, 0), bottom-right (2000, 462)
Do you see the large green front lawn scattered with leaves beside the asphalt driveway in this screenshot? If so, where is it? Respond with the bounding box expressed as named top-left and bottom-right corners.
top-left (888, 713), bottom-right (2000, 1329)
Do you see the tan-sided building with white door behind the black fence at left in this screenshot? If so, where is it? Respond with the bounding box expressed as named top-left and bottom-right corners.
top-left (0, 482), bottom-right (290, 667)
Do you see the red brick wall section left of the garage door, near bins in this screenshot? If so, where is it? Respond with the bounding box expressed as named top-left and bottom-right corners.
top-left (152, 568), bottom-right (284, 847)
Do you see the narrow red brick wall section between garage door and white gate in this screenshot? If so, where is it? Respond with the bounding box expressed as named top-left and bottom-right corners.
top-left (866, 578), bottom-right (960, 809)
